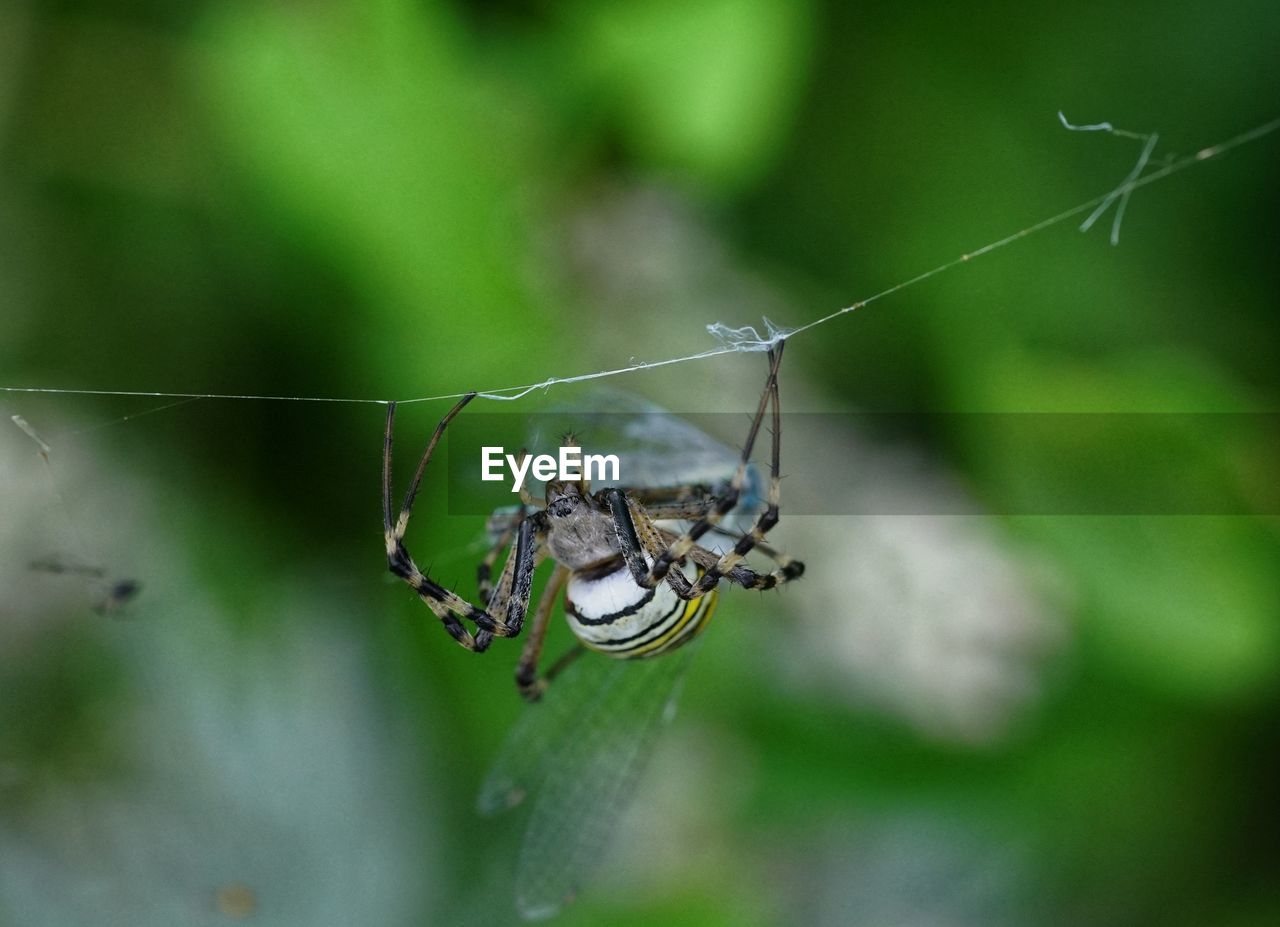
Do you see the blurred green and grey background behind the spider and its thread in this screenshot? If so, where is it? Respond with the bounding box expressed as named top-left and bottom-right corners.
top-left (0, 0), bottom-right (1280, 927)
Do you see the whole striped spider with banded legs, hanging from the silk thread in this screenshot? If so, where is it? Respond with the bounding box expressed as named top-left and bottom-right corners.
top-left (383, 343), bottom-right (804, 700)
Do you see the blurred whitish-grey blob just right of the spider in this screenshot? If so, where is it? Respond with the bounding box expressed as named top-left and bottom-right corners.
top-left (777, 431), bottom-right (1066, 744)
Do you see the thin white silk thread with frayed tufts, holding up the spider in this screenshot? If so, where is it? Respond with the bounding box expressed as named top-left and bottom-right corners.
top-left (0, 113), bottom-right (1280, 430)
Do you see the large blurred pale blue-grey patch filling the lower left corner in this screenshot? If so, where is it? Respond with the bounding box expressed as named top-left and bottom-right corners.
top-left (0, 422), bottom-right (434, 927)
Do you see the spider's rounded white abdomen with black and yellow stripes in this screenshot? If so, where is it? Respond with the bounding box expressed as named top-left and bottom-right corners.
top-left (564, 566), bottom-right (717, 658)
